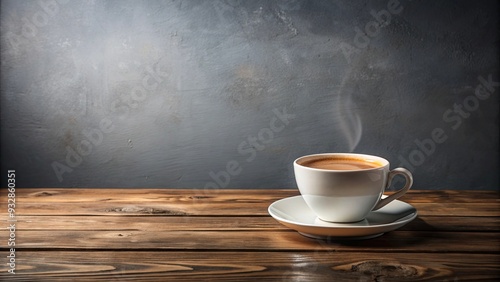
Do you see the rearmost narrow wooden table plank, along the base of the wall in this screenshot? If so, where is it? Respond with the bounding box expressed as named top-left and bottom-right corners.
top-left (8, 188), bottom-right (500, 203)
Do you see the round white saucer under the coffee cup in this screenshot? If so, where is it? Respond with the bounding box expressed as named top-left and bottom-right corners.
top-left (268, 196), bottom-right (417, 240)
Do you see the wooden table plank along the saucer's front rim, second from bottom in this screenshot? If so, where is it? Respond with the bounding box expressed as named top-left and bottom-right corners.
top-left (0, 230), bottom-right (500, 253)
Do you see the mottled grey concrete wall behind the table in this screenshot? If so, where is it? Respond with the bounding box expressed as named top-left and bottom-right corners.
top-left (0, 0), bottom-right (500, 189)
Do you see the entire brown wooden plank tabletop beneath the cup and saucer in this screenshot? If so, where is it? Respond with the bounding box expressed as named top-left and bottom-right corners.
top-left (0, 188), bottom-right (500, 281)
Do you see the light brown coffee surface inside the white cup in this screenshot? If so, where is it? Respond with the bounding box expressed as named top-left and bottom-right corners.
top-left (299, 157), bottom-right (382, 170)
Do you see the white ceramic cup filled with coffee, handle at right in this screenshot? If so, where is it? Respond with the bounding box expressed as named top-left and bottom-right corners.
top-left (293, 153), bottom-right (413, 222)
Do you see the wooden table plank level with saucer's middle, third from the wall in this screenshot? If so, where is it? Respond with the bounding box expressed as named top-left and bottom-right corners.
top-left (0, 215), bottom-right (500, 232)
